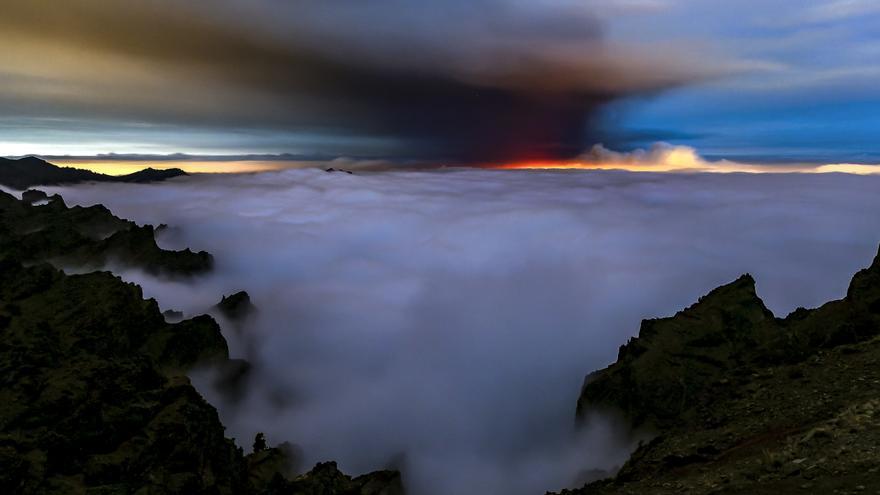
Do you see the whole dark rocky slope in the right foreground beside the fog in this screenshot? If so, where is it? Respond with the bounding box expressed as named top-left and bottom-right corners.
top-left (565, 248), bottom-right (880, 495)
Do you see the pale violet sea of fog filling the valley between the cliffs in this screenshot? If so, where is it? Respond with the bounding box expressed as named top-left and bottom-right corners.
top-left (49, 170), bottom-right (880, 495)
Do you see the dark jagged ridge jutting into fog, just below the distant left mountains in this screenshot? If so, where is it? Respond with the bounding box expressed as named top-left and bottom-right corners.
top-left (0, 192), bottom-right (213, 276)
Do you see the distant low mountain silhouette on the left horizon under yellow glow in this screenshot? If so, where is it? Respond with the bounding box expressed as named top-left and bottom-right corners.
top-left (0, 156), bottom-right (187, 189)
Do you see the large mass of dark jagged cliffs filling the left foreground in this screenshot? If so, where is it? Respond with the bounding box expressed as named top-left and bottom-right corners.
top-left (0, 195), bottom-right (401, 495)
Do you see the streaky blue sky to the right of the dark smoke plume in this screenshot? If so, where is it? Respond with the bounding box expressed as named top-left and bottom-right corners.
top-left (615, 0), bottom-right (880, 163)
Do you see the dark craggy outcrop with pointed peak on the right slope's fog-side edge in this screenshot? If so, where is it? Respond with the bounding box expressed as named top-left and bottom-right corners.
top-left (578, 276), bottom-right (778, 427)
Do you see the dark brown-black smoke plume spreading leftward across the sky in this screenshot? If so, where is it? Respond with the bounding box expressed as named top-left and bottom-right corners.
top-left (0, 0), bottom-right (723, 161)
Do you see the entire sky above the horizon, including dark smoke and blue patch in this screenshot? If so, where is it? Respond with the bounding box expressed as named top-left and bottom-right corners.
top-left (0, 0), bottom-right (880, 168)
